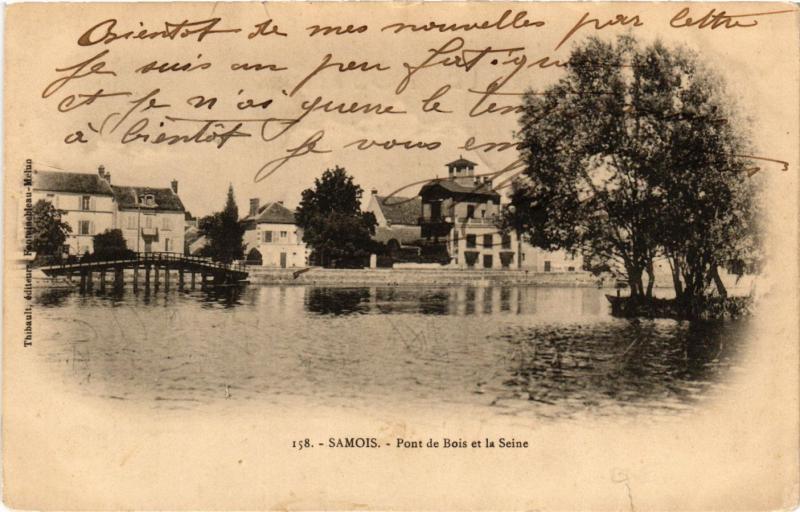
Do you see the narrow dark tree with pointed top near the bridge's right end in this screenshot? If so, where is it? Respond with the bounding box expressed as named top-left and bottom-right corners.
top-left (198, 185), bottom-right (245, 263)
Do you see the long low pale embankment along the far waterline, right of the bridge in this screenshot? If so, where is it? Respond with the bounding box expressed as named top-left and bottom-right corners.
top-left (247, 267), bottom-right (599, 287)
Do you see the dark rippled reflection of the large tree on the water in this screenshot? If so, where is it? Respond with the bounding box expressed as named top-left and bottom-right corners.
top-left (502, 320), bottom-right (741, 415)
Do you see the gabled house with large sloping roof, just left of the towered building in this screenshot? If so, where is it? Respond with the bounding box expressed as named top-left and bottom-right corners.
top-left (366, 189), bottom-right (422, 250)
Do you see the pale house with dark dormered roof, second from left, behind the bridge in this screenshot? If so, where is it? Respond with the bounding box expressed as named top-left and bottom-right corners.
top-left (111, 180), bottom-right (186, 254)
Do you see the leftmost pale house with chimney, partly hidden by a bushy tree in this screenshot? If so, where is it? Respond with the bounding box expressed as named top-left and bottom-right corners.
top-left (32, 166), bottom-right (116, 255)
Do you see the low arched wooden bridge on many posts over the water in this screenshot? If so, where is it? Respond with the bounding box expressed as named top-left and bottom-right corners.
top-left (40, 252), bottom-right (248, 291)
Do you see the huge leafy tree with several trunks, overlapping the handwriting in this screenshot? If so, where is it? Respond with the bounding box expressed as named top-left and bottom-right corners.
top-left (508, 36), bottom-right (758, 308)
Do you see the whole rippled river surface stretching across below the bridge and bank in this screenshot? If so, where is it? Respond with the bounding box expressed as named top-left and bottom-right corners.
top-left (34, 286), bottom-right (746, 417)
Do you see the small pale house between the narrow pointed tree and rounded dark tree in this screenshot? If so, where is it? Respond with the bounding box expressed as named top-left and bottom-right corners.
top-left (242, 198), bottom-right (308, 268)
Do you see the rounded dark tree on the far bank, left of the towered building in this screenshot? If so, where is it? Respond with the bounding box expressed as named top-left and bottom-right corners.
top-left (297, 166), bottom-right (377, 266)
